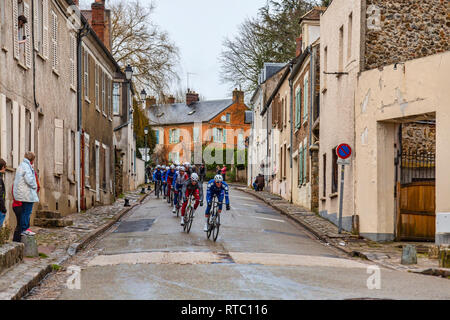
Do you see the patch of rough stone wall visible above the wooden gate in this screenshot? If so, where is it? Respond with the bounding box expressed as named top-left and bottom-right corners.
top-left (402, 123), bottom-right (436, 154)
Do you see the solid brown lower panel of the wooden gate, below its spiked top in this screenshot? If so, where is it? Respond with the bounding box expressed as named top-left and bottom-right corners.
top-left (397, 181), bottom-right (436, 241)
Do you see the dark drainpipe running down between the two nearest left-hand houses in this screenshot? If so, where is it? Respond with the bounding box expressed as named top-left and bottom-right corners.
top-left (75, 24), bottom-right (89, 212)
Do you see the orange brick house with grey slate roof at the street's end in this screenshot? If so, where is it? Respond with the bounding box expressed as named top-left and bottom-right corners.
top-left (147, 89), bottom-right (250, 168)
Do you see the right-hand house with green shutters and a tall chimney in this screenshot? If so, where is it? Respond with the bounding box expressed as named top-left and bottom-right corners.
top-left (264, 7), bottom-right (324, 210)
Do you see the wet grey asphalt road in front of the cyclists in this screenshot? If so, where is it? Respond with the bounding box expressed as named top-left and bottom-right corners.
top-left (43, 189), bottom-right (450, 300)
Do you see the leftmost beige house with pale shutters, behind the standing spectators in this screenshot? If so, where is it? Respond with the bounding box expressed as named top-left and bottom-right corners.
top-left (0, 0), bottom-right (77, 228)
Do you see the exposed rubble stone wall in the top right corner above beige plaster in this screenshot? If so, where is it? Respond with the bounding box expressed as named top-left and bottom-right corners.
top-left (364, 0), bottom-right (450, 70)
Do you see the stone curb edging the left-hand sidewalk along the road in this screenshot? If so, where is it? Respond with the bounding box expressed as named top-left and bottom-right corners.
top-left (8, 190), bottom-right (153, 300)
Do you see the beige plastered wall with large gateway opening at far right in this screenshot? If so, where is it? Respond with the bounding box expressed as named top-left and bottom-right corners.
top-left (354, 51), bottom-right (450, 244)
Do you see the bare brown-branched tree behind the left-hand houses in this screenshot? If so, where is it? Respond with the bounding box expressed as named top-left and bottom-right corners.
top-left (109, 0), bottom-right (179, 94)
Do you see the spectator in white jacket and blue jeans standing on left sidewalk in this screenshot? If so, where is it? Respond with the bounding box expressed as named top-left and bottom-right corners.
top-left (14, 152), bottom-right (39, 235)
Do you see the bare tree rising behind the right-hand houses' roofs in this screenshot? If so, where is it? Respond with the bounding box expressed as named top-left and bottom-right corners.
top-left (219, 0), bottom-right (318, 92)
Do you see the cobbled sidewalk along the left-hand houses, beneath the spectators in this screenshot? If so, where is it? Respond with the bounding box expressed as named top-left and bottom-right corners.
top-left (0, 188), bottom-right (153, 300)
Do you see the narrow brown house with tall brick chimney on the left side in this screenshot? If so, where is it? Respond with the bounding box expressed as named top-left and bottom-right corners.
top-left (80, 0), bottom-right (124, 209)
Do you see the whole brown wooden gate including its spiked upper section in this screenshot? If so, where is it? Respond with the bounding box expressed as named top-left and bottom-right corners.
top-left (397, 153), bottom-right (436, 241)
